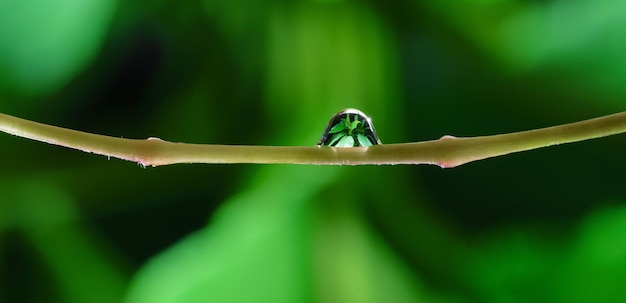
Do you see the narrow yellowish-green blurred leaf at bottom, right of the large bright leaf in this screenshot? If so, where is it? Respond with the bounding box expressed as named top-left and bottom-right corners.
top-left (312, 194), bottom-right (424, 303)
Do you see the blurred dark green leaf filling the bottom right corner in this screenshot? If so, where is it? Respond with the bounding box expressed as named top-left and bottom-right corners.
top-left (467, 202), bottom-right (626, 303)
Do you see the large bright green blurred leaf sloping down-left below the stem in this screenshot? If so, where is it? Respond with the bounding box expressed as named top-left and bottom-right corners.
top-left (126, 166), bottom-right (339, 303)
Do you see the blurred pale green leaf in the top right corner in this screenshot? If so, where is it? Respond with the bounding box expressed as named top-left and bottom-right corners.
top-left (421, 0), bottom-right (626, 100)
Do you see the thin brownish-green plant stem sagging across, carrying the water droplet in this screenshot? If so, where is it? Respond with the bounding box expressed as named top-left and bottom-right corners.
top-left (0, 112), bottom-right (626, 168)
